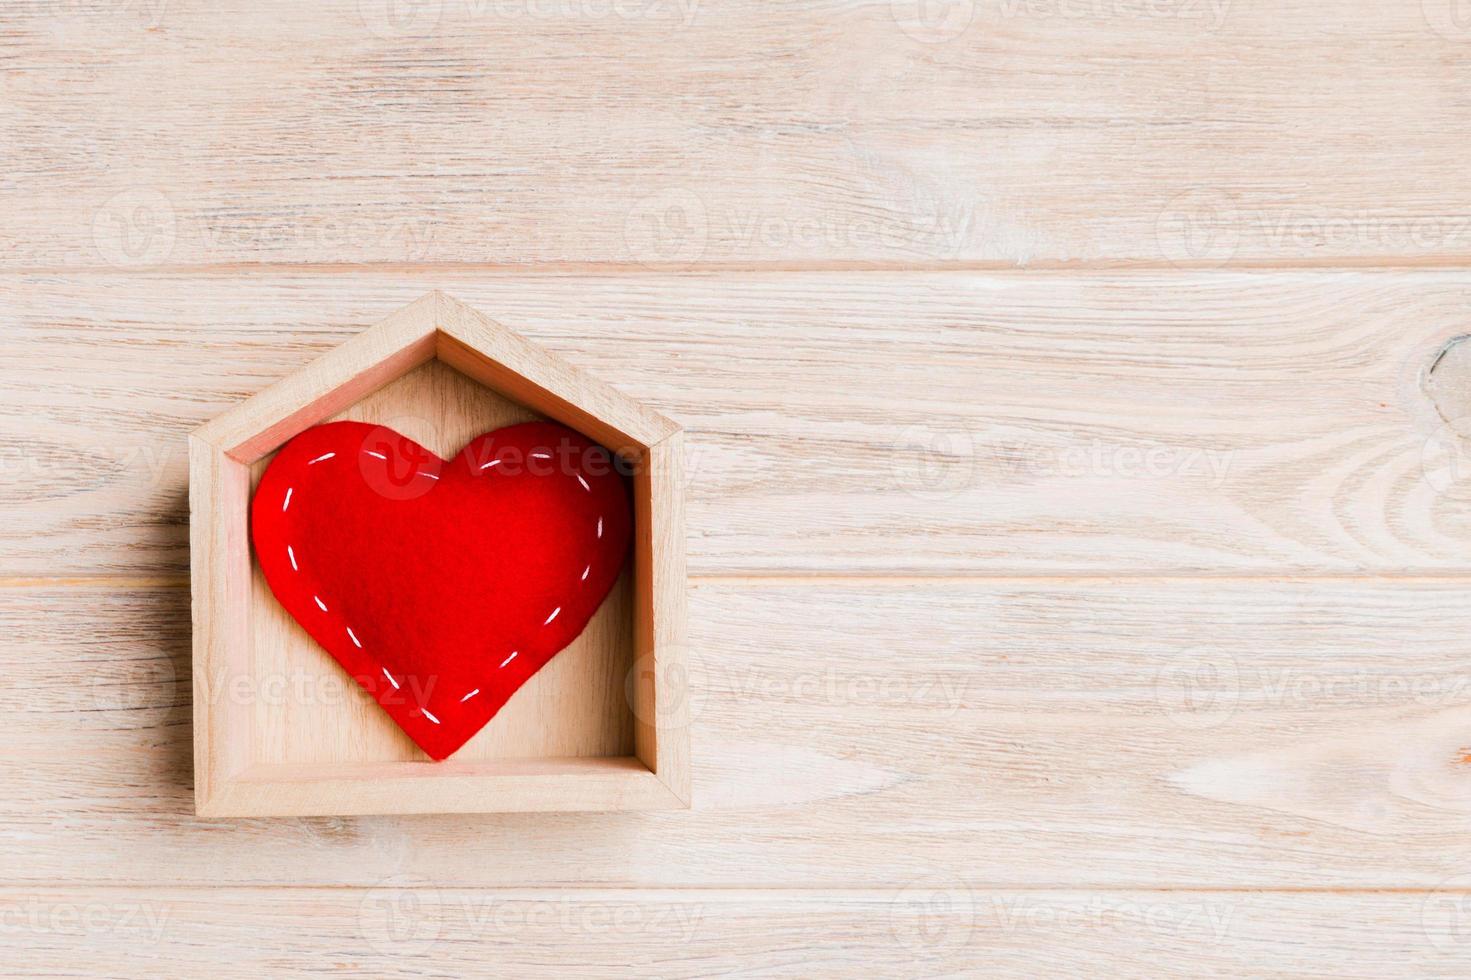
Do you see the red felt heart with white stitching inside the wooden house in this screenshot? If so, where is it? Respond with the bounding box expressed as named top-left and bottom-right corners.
top-left (250, 422), bottom-right (633, 759)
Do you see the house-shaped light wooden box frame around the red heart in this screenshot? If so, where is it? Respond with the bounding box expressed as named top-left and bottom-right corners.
top-left (190, 293), bottom-right (690, 817)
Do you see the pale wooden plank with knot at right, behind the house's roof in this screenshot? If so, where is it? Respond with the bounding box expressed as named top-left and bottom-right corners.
top-left (0, 272), bottom-right (1471, 577)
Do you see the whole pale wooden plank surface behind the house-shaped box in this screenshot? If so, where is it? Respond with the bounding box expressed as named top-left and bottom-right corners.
top-left (0, 0), bottom-right (1471, 977)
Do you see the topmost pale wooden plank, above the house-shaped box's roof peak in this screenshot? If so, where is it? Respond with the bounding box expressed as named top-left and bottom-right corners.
top-left (0, 0), bottom-right (1471, 268)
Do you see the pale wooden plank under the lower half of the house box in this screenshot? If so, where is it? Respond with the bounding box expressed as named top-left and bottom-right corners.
top-left (0, 580), bottom-right (1471, 889)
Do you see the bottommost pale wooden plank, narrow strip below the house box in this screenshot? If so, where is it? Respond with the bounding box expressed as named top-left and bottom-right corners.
top-left (0, 881), bottom-right (1471, 980)
